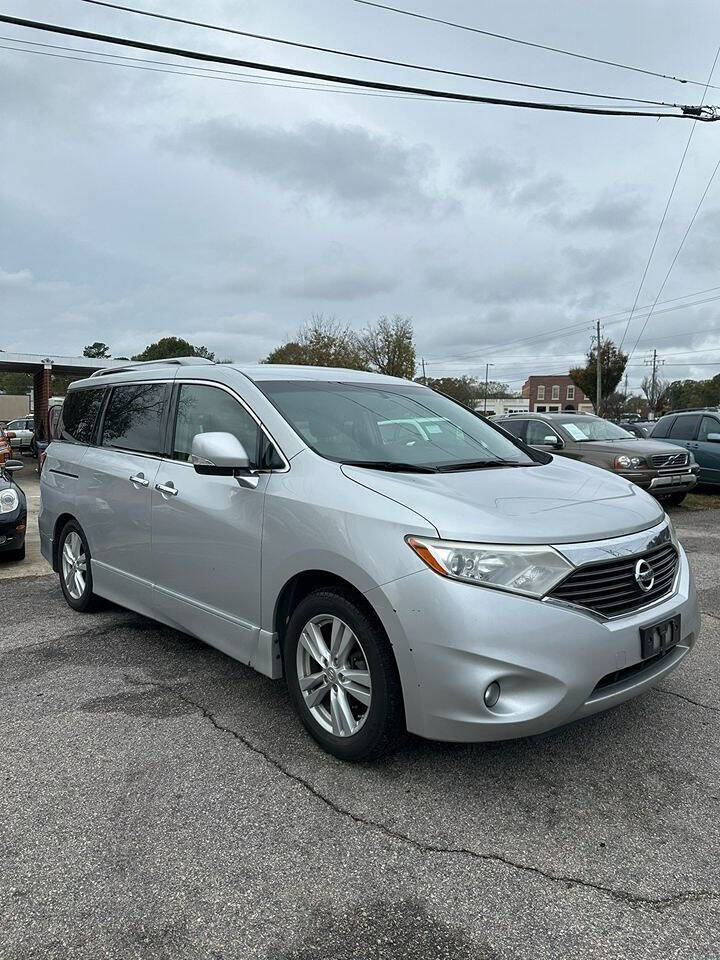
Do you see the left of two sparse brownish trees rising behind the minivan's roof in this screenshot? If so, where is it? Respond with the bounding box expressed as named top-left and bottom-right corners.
top-left (262, 313), bottom-right (369, 370)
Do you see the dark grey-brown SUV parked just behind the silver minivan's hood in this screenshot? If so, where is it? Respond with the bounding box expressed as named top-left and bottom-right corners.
top-left (496, 413), bottom-right (696, 506)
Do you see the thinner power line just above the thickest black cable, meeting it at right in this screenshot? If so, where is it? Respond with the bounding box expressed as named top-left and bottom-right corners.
top-left (70, 0), bottom-right (681, 108)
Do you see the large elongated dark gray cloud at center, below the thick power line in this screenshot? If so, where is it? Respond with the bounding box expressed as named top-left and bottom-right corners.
top-left (166, 118), bottom-right (452, 212)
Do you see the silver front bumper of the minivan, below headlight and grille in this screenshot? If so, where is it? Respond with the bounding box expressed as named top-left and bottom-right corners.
top-left (367, 548), bottom-right (700, 741)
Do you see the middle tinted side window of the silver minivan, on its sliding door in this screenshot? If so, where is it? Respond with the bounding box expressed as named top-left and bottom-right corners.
top-left (102, 383), bottom-right (168, 453)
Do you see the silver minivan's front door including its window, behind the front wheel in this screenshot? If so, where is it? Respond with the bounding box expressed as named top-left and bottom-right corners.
top-left (152, 383), bottom-right (269, 662)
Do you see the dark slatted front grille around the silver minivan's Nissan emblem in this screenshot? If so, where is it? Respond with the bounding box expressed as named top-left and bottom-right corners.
top-left (549, 543), bottom-right (678, 617)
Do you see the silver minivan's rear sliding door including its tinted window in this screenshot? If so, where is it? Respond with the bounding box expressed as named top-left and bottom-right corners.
top-left (79, 381), bottom-right (170, 610)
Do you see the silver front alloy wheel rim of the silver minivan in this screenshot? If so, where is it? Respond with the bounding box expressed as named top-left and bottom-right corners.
top-left (296, 615), bottom-right (372, 737)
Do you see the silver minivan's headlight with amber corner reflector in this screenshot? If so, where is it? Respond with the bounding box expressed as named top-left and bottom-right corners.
top-left (407, 537), bottom-right (575, 597)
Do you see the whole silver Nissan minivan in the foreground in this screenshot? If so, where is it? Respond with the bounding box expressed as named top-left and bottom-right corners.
top-left (40, 358), bottom-right (699, 760)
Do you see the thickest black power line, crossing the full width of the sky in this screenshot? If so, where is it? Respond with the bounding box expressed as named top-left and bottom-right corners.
top-left (0, 14), bottom-right (720, 121)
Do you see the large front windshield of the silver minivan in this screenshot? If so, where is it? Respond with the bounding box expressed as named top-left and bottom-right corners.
top-left (257, 380), bottom-right (536, 470)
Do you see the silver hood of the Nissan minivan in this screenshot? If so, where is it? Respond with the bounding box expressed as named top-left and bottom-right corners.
top-left (342, 457), bottom-right (664, 543)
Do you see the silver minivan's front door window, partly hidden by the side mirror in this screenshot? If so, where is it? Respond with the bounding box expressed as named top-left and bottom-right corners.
top-left (173, 383), bottom-right (262, 466)
